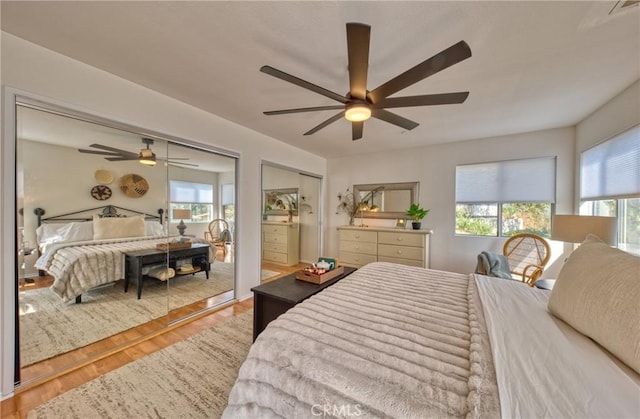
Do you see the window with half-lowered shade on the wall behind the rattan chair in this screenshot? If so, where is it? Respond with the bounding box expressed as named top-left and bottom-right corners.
top-left (456, 157), bottom-right (556, 237)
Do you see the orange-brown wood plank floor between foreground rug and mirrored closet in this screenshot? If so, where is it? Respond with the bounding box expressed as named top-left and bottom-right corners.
top-left (0, 262), bottom-right (307, 419)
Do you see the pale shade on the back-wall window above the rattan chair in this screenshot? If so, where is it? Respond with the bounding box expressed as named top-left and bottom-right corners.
top-left (456, 157), bottom-right (556, 204)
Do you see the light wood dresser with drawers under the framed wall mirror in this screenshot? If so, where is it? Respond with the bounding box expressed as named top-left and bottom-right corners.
top-left (338, 226), bottom-right (432, 268)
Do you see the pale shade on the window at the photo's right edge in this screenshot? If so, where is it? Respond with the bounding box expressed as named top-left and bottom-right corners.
top-left (580, 125), bottom-right (640, 201)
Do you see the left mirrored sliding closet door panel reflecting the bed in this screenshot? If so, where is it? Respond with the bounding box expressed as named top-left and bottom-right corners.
top-left (15, 100), bottom-right (168, 383)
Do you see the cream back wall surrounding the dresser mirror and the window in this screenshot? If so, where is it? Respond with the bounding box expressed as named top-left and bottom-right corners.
top-left (325, 128), bottom-right (575, 277)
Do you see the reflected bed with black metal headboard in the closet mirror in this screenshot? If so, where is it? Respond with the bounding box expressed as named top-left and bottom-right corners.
top-left (34, 205), bottom-right (214, 302)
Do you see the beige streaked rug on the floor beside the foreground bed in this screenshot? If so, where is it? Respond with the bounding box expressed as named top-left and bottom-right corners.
top-left (27, 311), bottom-right (253, 419)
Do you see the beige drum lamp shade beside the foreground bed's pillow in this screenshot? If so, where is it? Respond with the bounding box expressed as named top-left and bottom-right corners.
top-left (551, 215), bottom-right (617, 245)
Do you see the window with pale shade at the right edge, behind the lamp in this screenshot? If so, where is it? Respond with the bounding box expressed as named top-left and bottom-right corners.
top-left (580, 125), bottom-right (640, 255)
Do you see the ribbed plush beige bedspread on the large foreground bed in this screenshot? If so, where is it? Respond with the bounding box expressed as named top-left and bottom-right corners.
top-left (223, 262), bottom-right (500, 418)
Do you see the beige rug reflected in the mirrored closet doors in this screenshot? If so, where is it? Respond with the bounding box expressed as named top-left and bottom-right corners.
top-left (20, 262), bottom-right (238, 367)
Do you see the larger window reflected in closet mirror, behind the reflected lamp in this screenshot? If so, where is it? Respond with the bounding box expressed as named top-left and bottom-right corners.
top-left (169, 180), bottom-right (214, 223)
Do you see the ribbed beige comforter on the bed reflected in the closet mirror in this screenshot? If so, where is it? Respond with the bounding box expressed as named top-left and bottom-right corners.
top-left (35, 236), bottom-right (213, 302)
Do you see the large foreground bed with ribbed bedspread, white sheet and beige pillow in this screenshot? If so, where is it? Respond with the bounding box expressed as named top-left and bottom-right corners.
top-left (223, 235), bottom-right (640, 418)
